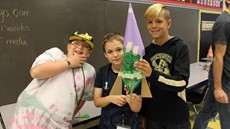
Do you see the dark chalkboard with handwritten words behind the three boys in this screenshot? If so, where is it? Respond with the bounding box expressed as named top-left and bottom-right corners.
top-left (0, 0), bottom-right (198, 106)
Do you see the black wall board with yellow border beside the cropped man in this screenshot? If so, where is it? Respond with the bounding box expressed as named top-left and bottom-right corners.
top-left (197, 10), bottom-right (221, 61)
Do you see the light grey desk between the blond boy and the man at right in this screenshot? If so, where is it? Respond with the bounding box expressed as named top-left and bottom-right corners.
top-left (187, 62), bottom-right (208, 91)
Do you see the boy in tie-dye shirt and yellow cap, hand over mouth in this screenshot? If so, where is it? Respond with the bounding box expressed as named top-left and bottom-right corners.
top-left (11, 32), bottom-right (96, 129)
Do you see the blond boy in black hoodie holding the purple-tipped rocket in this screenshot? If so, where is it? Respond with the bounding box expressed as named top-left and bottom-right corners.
top-left (135, 4), bottom-right (190, 129)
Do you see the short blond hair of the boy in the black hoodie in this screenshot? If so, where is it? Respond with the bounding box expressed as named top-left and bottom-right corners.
top-left (144, 4), bottom-right (171, 21)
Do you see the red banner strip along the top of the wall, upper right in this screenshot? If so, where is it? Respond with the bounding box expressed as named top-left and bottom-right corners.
top-left (151, 0), bottom-right (223, 10)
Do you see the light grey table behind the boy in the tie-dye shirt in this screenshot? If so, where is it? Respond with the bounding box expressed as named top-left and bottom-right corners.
top-left (0, 101), bottom-right (101, 129)
